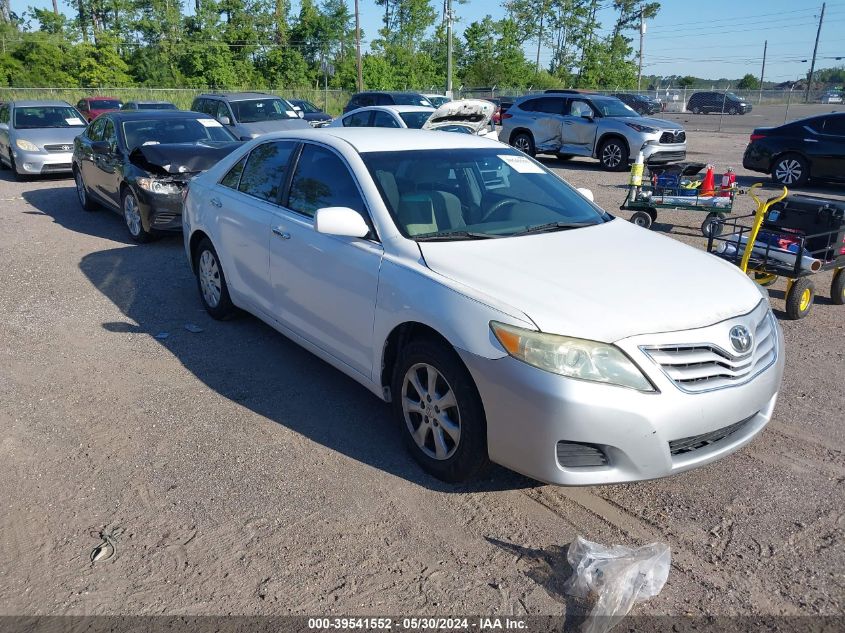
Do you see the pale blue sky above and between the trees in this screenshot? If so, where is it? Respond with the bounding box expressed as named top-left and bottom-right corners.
top-left (11, 0), bottom-right (845, 82)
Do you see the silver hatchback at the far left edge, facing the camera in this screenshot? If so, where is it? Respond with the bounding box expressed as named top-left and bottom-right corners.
top-left (0, 101), bottom-right (85, 178)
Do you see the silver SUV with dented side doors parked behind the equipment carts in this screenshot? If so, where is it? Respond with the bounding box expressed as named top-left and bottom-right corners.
top-left (499, 91), bottom-right (687, 171)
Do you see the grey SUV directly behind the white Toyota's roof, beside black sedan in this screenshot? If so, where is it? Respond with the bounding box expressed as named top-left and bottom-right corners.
top-left (191, 92), bottom-right (311, 141)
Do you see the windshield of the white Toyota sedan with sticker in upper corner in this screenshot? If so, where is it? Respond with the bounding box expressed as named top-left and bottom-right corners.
top-left (361, 146), bottom-right (611, 241)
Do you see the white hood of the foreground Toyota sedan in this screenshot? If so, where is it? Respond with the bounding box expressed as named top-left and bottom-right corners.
top-left (419, 218), bottom-right (760, 343)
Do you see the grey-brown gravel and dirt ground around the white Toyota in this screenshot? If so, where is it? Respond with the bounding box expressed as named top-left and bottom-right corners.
top-left (0, 128), bottom-right (845, 615)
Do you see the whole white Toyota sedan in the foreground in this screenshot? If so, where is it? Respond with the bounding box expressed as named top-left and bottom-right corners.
top-left (183, 127), bottom-right (784, 485)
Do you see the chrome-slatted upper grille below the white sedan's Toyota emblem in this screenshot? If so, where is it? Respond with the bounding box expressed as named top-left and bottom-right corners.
top-left (641, 309), bottom-right (777, 393)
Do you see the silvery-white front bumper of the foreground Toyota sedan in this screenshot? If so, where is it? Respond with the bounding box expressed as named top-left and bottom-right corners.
top-left (461, 308), bottom-right (784, 486)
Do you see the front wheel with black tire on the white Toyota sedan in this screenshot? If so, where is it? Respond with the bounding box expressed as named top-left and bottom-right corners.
top-left (391, 338), bottom-right (490, 483)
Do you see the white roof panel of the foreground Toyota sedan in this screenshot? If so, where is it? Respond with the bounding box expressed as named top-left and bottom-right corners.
top-left (261, 127), bottom-right (504, 154)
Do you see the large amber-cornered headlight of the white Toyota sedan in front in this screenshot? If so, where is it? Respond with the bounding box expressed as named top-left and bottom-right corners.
top-left (490, 321), bottom-right (654, 391)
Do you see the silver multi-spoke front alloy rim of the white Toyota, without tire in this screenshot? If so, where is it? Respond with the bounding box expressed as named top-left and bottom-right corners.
top-left (402, 363), bottom-right (461, 460)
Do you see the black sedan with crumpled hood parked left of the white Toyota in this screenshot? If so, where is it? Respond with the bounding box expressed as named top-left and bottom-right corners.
top-left (72, 110), bottom-right (242, 242)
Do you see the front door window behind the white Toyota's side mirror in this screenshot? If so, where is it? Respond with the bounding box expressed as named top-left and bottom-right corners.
top-left (287, 143), bottom-right (367, 218)
